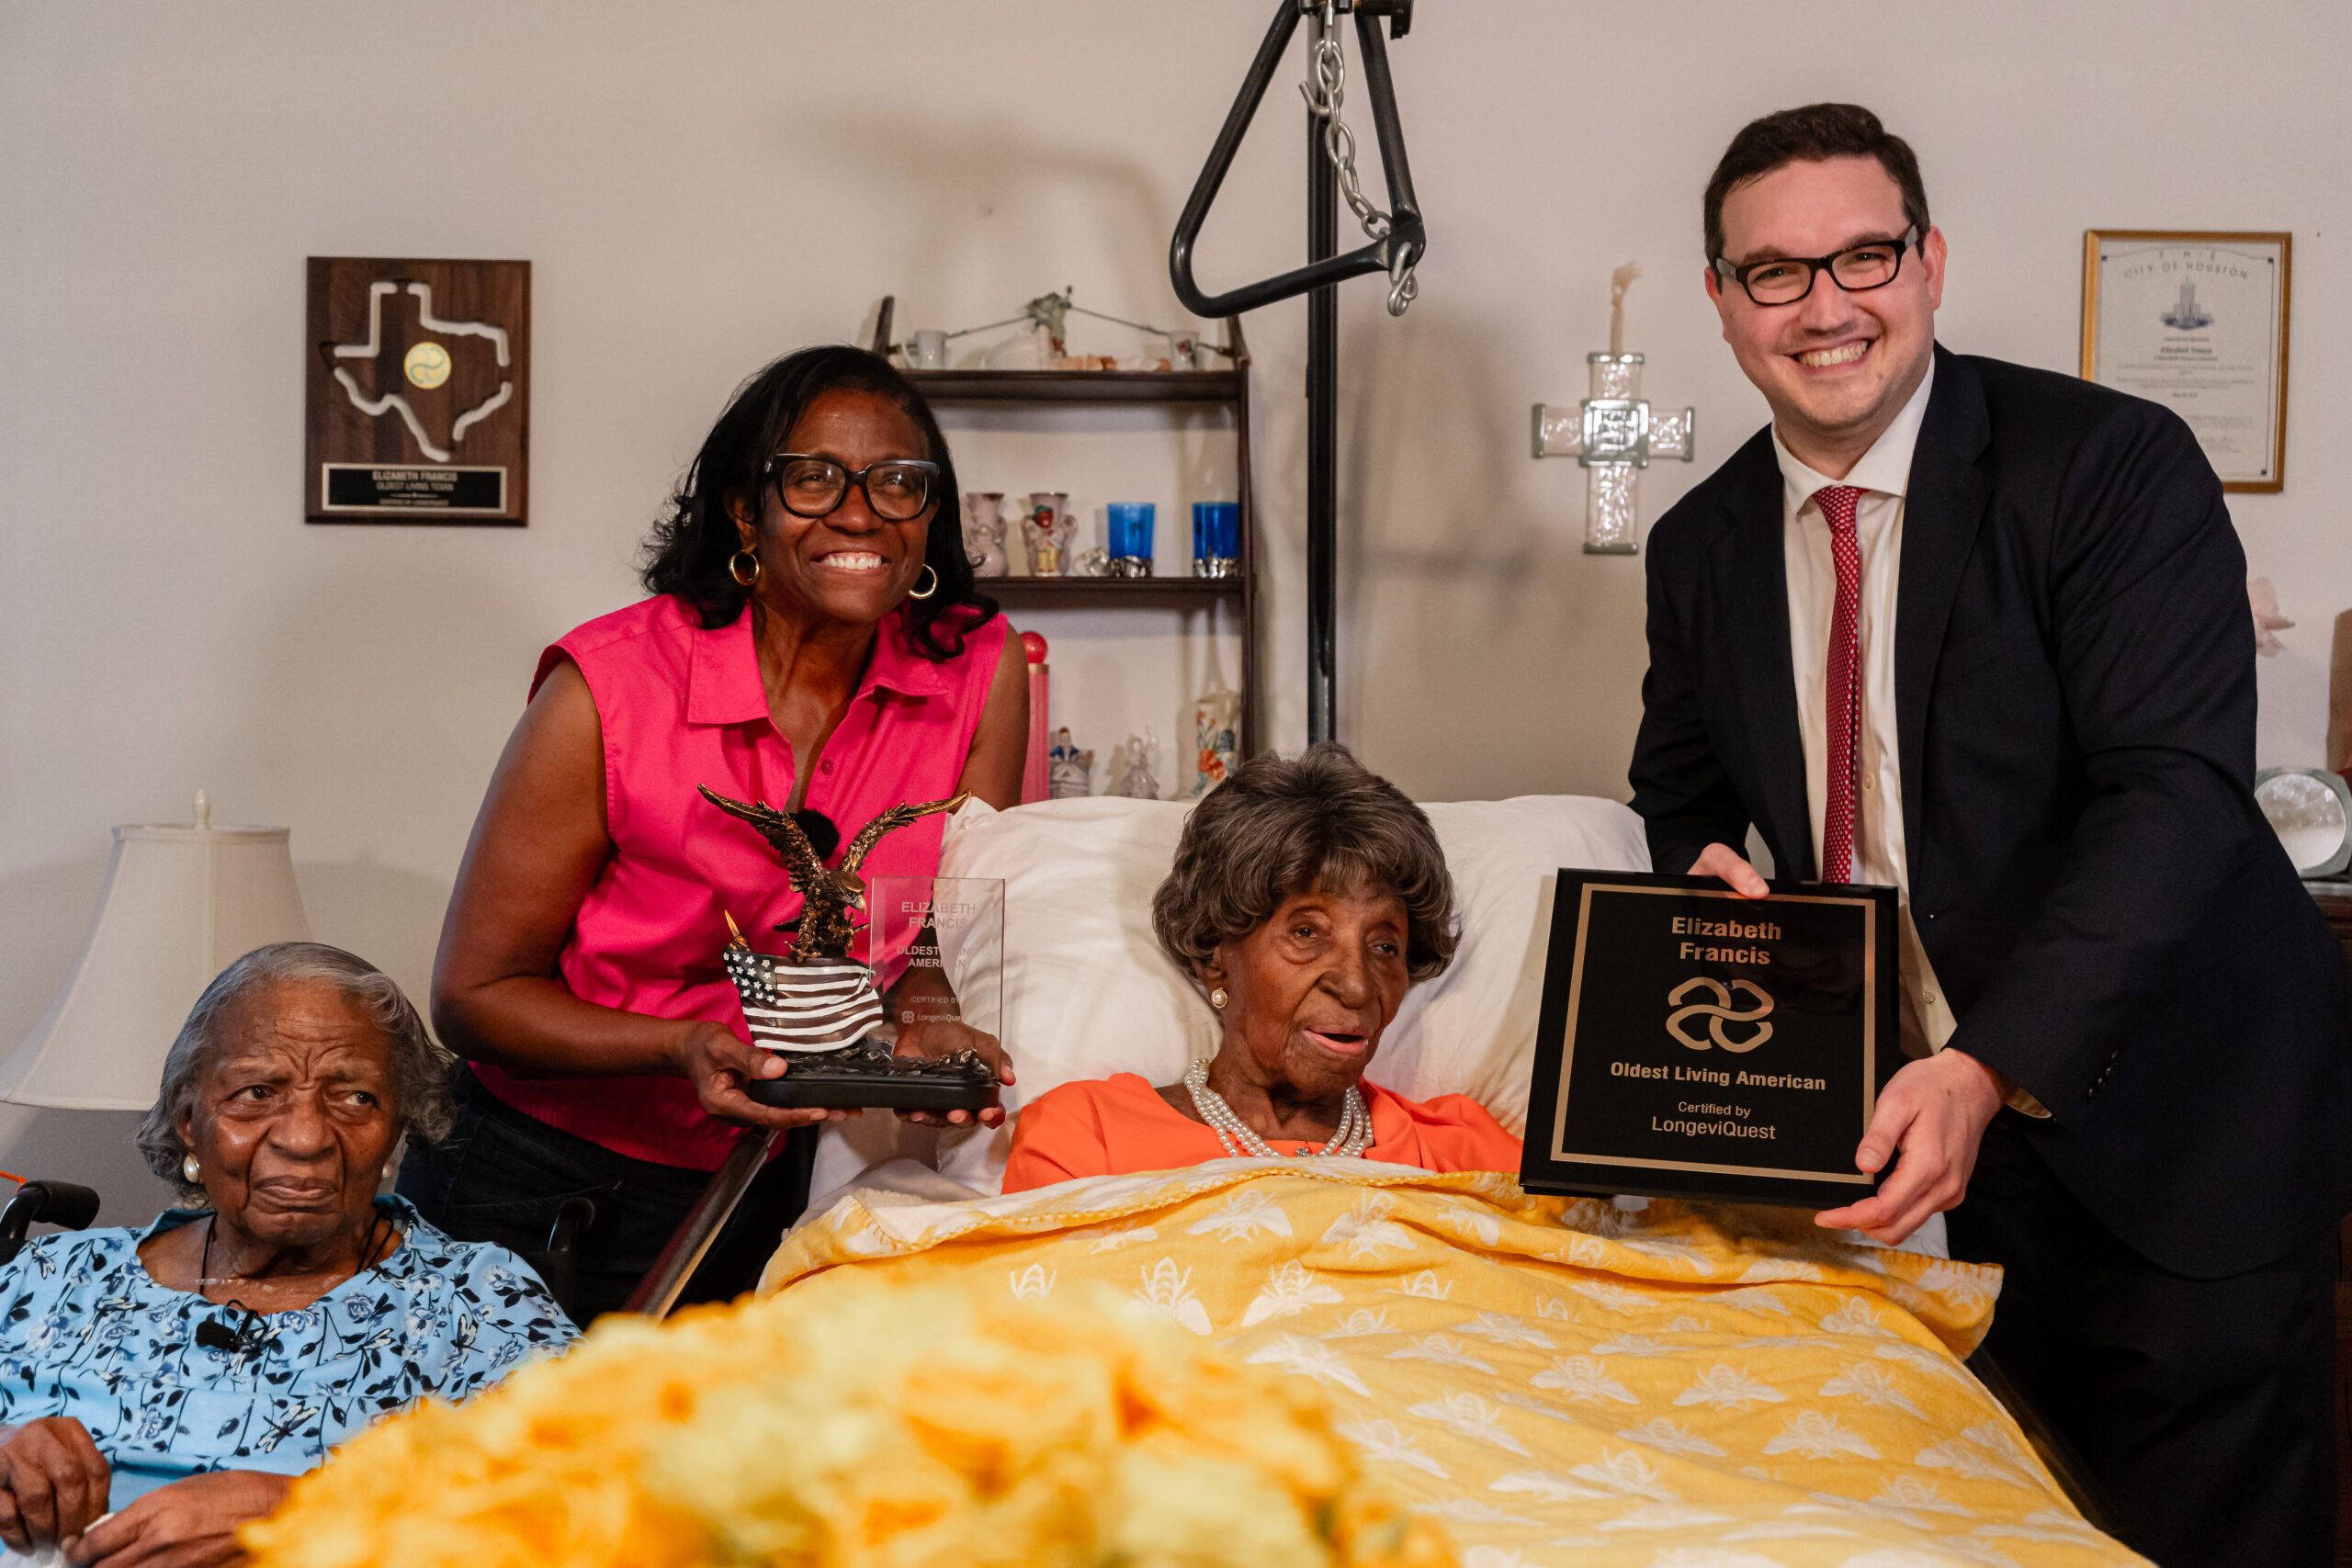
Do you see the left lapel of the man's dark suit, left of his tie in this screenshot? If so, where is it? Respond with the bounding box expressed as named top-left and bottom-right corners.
top-left (1714, 428), bottom-right (1818, 882)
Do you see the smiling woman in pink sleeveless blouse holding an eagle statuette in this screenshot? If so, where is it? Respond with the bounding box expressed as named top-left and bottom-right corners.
top-left (400, 348), bottom-right (1028, 1324)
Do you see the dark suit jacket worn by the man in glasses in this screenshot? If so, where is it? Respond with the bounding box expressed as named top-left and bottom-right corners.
top-left (1633, 348), bottom-right (2352, 1277)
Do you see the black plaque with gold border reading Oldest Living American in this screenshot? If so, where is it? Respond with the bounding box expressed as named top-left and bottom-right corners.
top-left (1520, 870), bottom-right (1903, 1208)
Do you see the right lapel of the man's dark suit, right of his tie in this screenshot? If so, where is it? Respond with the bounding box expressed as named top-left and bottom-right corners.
top-left (1900, 345), bottom-right (1992, 886)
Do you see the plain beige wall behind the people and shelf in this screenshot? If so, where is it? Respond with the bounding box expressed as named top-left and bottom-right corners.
top-left (0, 0), bottom-right (2352, 1218)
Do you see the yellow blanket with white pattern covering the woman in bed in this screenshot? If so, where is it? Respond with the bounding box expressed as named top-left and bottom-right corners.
top-left (762, 1161), bottom-right (2143, 1568)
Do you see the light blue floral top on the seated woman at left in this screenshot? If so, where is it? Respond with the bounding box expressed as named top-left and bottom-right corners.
top-left (0, 1197), bottom-right (579, 1509)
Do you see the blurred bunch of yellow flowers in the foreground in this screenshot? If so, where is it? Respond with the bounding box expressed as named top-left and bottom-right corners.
top-left (244, 1281), bottom-right (1453, 1568)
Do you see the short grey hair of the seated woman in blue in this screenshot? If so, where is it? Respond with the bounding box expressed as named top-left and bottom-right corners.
top-left (136, 942), bottom-right (457, 1203)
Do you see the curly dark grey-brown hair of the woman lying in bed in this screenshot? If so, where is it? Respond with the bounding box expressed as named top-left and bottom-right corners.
top-left (1152, 740), bottom-right (1461, 980)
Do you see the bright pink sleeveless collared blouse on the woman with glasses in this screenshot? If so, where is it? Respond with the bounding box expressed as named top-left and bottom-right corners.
top-left (473, 594), bottom-right (1007, 1170)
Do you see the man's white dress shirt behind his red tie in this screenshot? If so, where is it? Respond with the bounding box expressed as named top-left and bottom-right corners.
top-left (1771, 362), bottom-right (1957, 1055)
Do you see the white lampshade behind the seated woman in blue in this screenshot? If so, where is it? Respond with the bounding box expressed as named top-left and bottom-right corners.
top-left (0, 792), bottom-right (311, 1110)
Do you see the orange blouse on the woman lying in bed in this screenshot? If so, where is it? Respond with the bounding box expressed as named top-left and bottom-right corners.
top-left (1004, 1072), bottom-right (1520, 1192)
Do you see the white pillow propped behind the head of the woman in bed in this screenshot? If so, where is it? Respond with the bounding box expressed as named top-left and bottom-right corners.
top-left (875, 795), bottom-right (1649, 1192)
